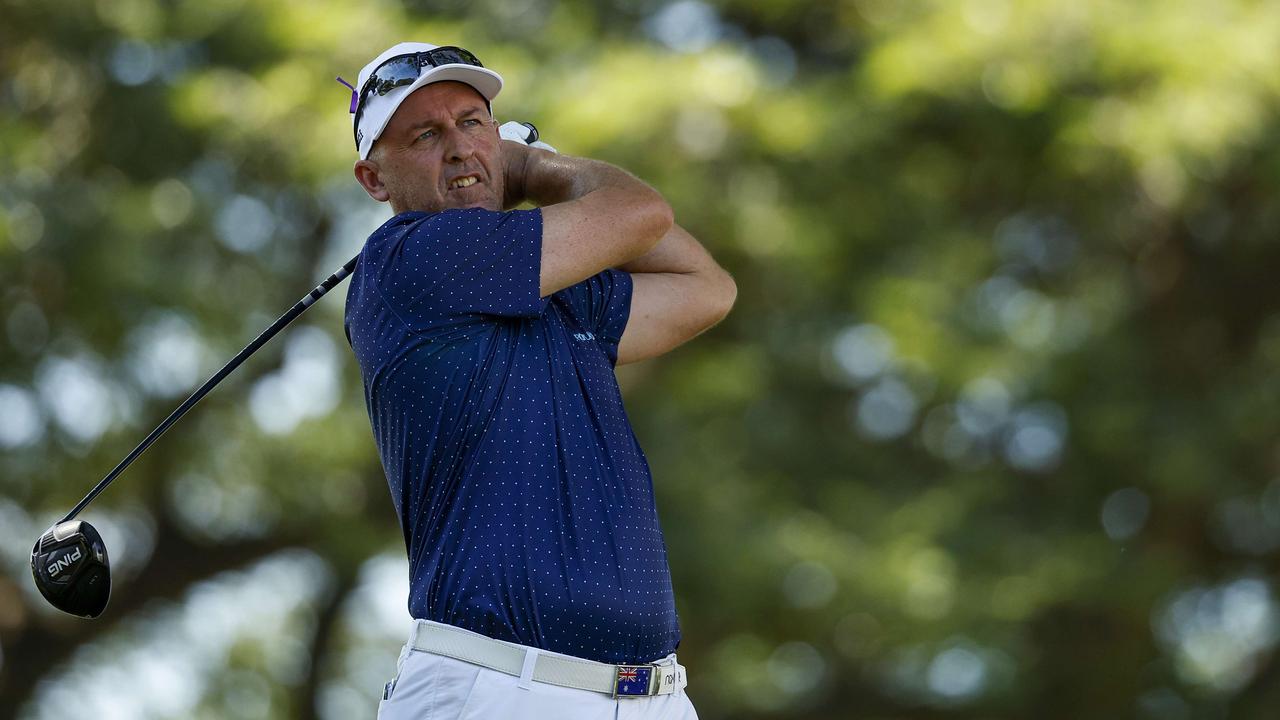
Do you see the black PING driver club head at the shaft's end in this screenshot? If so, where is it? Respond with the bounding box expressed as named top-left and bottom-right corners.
top-left (31, 520), bottom-right (111, 618)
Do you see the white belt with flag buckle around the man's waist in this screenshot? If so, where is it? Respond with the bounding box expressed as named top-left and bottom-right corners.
top-left (410, 621), bottom-right (689, 697)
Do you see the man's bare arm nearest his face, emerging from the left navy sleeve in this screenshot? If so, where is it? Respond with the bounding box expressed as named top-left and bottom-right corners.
top-left (502, 142), bottom-right (672, 297)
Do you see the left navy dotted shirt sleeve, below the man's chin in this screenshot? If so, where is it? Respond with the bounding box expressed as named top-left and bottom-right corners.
top-left (378, 209), bottom-right (547, 328)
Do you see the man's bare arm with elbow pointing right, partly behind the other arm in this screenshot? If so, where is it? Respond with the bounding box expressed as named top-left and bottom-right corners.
top-left (618, 224), bottom-right (737, 365)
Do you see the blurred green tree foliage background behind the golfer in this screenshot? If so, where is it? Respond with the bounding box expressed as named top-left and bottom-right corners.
top-left (0, 0), bottom-right (1280, 720)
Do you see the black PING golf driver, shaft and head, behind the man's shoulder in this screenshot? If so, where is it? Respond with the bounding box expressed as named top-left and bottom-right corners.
top-left (31, 255), bottom-right (360, 618)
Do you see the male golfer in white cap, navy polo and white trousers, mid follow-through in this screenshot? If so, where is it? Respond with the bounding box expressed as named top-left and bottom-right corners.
top-left (346, 42), bottom-right (736, 720)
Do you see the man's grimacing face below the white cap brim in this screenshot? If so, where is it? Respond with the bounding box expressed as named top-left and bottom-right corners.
top-left (356, 81), bottom-right (504, 213)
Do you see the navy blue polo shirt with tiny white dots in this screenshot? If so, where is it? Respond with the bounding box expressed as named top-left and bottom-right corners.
top-left (346, 209), bottom-right (680, 662)
